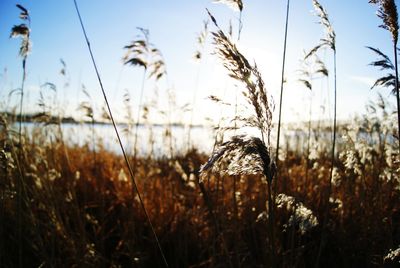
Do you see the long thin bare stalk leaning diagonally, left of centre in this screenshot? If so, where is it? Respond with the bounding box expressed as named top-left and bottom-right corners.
top-left (74, 0), bottom-right (168, 267)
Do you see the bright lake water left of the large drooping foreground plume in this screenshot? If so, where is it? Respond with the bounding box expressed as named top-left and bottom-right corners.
top-left (21, 123), bottom-right (214, 156)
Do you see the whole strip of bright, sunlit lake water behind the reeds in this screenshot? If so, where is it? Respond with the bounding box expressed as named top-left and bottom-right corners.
top-left (15, 123), bottom-right (384, 157)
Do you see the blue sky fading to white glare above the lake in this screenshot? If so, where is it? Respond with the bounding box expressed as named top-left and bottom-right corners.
top-left (0, 0), bottom-right (393, 123)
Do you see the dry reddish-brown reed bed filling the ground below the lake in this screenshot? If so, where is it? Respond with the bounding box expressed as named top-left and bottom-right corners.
top-left (0, 110), bottom-right (400, 267)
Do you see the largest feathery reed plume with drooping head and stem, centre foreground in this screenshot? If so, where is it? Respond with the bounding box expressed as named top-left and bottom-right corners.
top-left (205, 10), bottom-right (276, 267)
